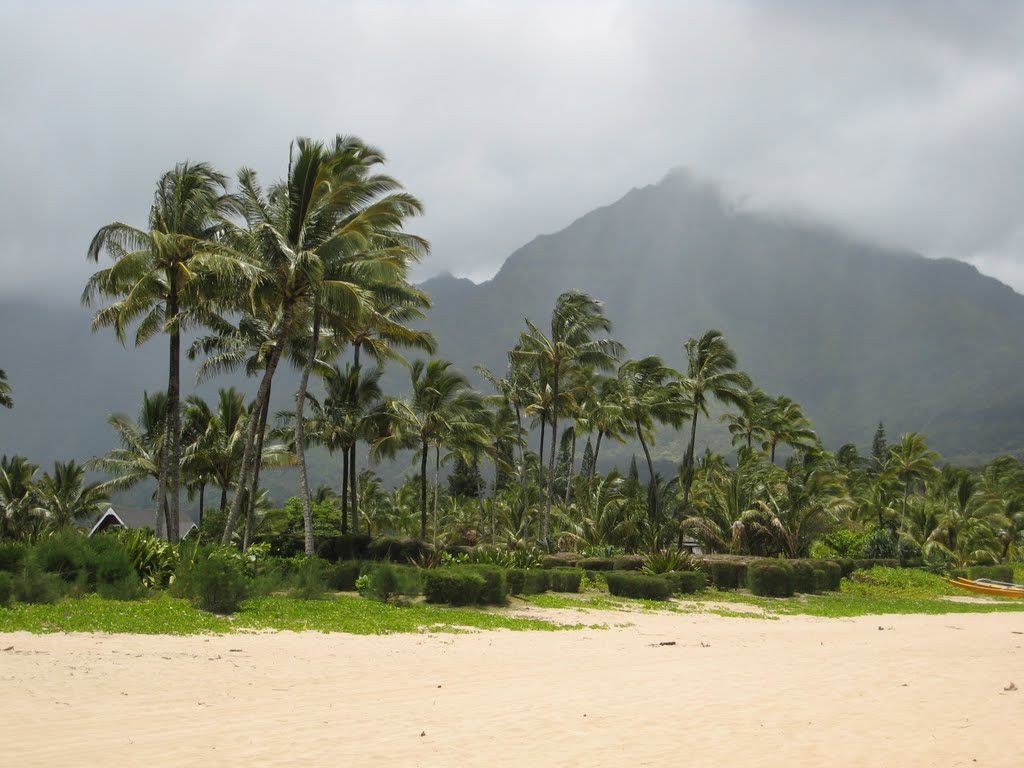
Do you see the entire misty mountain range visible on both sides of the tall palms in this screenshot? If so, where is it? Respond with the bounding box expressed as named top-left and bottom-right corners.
top-left (0, 172), bottom-right (1024, 502)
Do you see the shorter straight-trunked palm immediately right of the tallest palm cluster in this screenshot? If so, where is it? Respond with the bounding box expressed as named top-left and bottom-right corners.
top-left (373, 359), bottom-right (481, 541)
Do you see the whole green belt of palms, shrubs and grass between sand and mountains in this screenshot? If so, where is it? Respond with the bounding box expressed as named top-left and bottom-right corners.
top-left (0, 135), bottom-right (1024, 633)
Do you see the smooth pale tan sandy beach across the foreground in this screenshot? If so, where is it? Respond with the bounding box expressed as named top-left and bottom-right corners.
top-left (0, 610), bottom-right (1024, 768)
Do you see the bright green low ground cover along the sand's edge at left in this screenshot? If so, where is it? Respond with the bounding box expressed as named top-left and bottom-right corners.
top-left (0, 595), bottom-right (584, 635)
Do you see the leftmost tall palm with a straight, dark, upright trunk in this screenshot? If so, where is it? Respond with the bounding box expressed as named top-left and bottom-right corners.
top-left (82, 163), bottom-right (239, 542)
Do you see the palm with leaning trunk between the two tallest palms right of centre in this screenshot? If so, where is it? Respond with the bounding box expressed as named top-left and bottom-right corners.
top-left (616, 355), bottom-right (690, 530)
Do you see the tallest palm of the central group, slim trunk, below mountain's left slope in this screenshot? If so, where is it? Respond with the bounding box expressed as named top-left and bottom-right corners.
top-left (518, 291), bottom-right (623, 541)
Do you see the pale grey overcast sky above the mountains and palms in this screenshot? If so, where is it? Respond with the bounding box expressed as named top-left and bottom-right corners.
top-left (6, 0), bottom-right (1024, 302)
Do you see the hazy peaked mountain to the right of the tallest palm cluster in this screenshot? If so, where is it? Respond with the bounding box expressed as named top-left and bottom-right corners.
top-left (423, 171), bottom-right (1024, 463)
